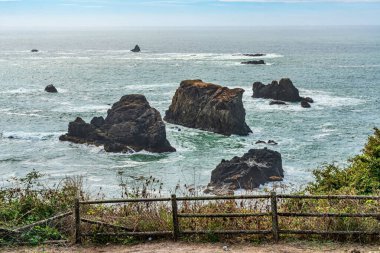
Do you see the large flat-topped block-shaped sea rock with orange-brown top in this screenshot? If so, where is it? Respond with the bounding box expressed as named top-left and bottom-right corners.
top-left (164, 80), bottom-right (252, 135)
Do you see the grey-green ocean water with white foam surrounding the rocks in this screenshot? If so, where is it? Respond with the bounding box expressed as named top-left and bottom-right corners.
top-left (0, 27), bottom-right (380, 196)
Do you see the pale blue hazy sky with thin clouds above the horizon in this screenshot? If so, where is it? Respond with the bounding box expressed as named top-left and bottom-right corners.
top-left (0, 0), bottom-right (380, 29)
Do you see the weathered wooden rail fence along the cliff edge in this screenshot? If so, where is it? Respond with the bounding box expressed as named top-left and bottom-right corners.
top-left (74, 192), bottom-right (380, 243)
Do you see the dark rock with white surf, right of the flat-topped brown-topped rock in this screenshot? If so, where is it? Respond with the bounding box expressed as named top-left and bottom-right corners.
top-left (252, 78), bottom-right (302, 102)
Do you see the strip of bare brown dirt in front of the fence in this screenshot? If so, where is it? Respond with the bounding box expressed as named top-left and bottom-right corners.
top-left (0, 242), bottom-right (380, 253)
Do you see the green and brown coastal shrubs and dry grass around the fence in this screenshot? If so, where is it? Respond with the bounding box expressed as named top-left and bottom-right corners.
top-left (0, 128), bottom-right (380, 245)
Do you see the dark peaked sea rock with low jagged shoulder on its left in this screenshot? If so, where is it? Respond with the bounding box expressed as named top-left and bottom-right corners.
top-left (60, 95), bottom-right (175, 153)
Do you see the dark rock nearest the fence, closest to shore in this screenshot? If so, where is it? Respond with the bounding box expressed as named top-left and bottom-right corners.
top-left (208, 148), bottom-right (284, 191)
